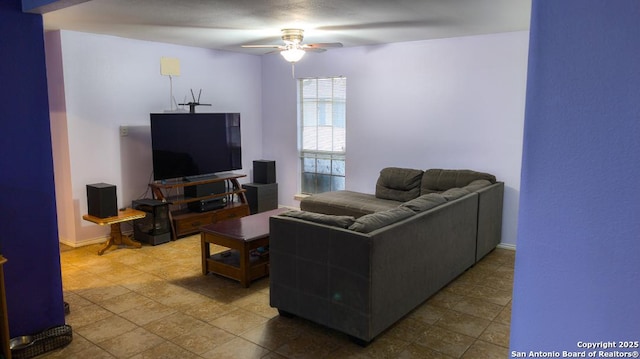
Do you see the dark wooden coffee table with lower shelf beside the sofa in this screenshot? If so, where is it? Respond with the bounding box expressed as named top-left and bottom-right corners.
top-left (200, 208), bottom-right (288, 287)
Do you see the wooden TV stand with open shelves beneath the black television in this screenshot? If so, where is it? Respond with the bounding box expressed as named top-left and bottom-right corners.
top-left (149, 173), bottom-right (249, 240)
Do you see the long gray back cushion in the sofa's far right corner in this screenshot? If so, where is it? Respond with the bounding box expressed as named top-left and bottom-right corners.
top-left (420, 169), bottom-right (496, 194)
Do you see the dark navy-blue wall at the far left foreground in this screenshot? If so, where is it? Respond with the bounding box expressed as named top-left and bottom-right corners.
top-left (0, 0), bottom-right (64, 337)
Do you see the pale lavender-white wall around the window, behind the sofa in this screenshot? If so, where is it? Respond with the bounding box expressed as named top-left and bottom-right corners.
top-left (262, 32), bottom-right (529, 245)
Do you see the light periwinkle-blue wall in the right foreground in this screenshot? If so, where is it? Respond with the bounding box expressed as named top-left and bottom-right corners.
top-left (511, 0), bottom-right (640, 356)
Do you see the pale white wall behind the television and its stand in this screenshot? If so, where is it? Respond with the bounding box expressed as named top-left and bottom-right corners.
top-left (46, 31), bottom-right (262, 246)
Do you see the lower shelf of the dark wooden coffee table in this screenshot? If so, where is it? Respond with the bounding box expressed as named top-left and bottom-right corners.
top-left (204, 249), bottom-right (269, 287)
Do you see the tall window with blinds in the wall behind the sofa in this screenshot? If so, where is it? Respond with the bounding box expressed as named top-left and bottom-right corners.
top-left (298, 77), bottom-right (347, 194)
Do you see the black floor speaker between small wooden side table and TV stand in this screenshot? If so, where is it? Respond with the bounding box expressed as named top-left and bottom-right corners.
top-left (131, 198), bottom-right (171, 246)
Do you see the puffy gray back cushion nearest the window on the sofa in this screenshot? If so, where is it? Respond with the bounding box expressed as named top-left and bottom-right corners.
top-left (376, 167), bottom-right (424, 202)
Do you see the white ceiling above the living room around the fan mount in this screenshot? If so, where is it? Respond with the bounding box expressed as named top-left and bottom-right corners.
top-left (36, 0), bottom-right (531, 54)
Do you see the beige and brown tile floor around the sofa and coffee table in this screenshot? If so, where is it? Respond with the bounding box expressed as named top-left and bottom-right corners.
top-left (40, 235), bottom-right (515, 359)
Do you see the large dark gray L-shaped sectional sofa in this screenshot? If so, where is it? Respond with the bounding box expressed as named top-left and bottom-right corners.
top-left (269, 168), bottom-right (504, 344)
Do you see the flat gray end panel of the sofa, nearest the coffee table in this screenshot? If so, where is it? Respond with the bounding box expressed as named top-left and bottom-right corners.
top-left (269, 216), bottom-right (371, 338)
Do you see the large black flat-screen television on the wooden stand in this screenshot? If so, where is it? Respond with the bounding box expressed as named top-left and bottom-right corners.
top-left (151, 113), bottom-right (242, 181)
